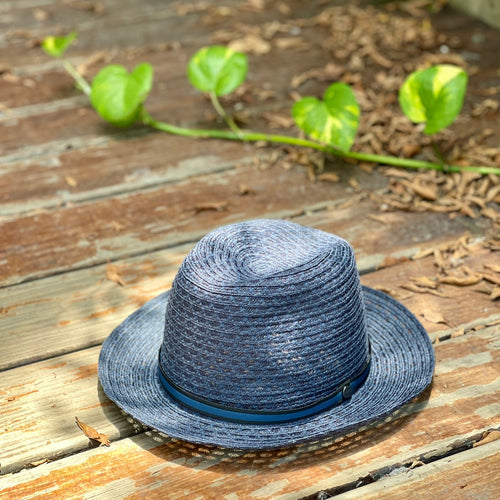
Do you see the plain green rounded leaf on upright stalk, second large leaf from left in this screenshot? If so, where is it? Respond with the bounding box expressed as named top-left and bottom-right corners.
top-left (187, 45), bottom-right (248, 96)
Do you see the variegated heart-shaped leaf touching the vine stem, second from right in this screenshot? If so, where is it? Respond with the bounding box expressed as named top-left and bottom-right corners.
top-left (292, 83), bottom-right (359, 151)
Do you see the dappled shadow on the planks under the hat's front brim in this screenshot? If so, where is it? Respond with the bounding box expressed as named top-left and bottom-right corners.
top-left (104, 383), bottom-right (432, 474)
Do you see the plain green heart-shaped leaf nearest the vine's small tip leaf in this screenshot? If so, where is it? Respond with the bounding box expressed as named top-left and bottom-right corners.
top-left (90, 63), bottom-right (153, 127)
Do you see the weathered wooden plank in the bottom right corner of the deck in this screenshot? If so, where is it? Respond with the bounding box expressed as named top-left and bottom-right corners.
top-left (335, 440), bottom-right (500, 500)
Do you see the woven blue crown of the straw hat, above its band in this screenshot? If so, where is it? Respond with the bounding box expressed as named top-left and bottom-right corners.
top-left (160, 220), bottom-right (369, 411)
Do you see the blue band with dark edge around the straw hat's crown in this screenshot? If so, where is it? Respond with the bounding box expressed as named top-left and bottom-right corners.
top-left (158, 356), bottom-right (371, 424)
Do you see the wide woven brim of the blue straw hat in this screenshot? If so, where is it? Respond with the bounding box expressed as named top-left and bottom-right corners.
top-left (99, 287), bottom-right (434, 449)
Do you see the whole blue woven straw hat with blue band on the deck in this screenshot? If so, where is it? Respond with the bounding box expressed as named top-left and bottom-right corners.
top-left (99, 220), bottom-right (434, 449)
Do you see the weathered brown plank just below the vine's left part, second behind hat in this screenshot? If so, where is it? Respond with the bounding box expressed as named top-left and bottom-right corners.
top-left (0, 134), bottom-right (256, 217)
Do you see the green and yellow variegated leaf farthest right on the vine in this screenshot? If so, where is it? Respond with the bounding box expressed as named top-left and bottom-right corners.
top-left (399, 64), bottom-right (467, 134)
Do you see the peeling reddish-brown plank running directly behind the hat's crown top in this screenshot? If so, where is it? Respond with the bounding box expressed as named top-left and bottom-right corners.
top-left (0, 165), bottom-right (385, 286)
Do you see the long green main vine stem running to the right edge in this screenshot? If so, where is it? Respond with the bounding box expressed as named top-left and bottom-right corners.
top-left (141, 108), bottom-right (500, 175)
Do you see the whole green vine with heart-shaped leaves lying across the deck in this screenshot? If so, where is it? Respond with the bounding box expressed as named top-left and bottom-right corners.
top-left (42, 32), bottom-right (500, 175)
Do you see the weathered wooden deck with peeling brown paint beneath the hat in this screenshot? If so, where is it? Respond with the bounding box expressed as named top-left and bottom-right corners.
top-left (0, 0), bottom-right (500, 500)
